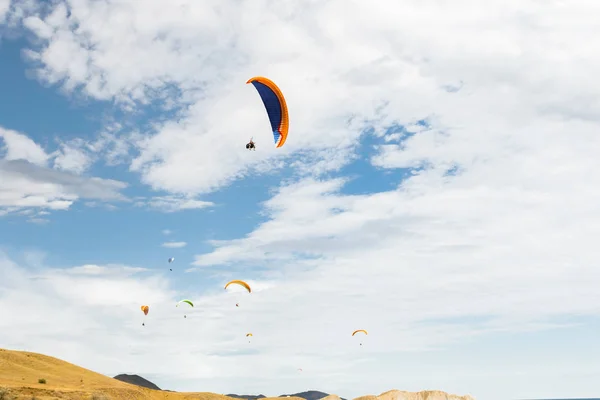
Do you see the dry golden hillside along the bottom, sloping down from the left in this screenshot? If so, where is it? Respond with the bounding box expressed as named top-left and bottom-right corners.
top-left (0, 349), bottom-right (473, 400)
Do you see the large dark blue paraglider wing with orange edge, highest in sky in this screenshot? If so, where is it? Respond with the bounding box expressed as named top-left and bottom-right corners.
top-left (246, 76), bottom-right (290, 147)
